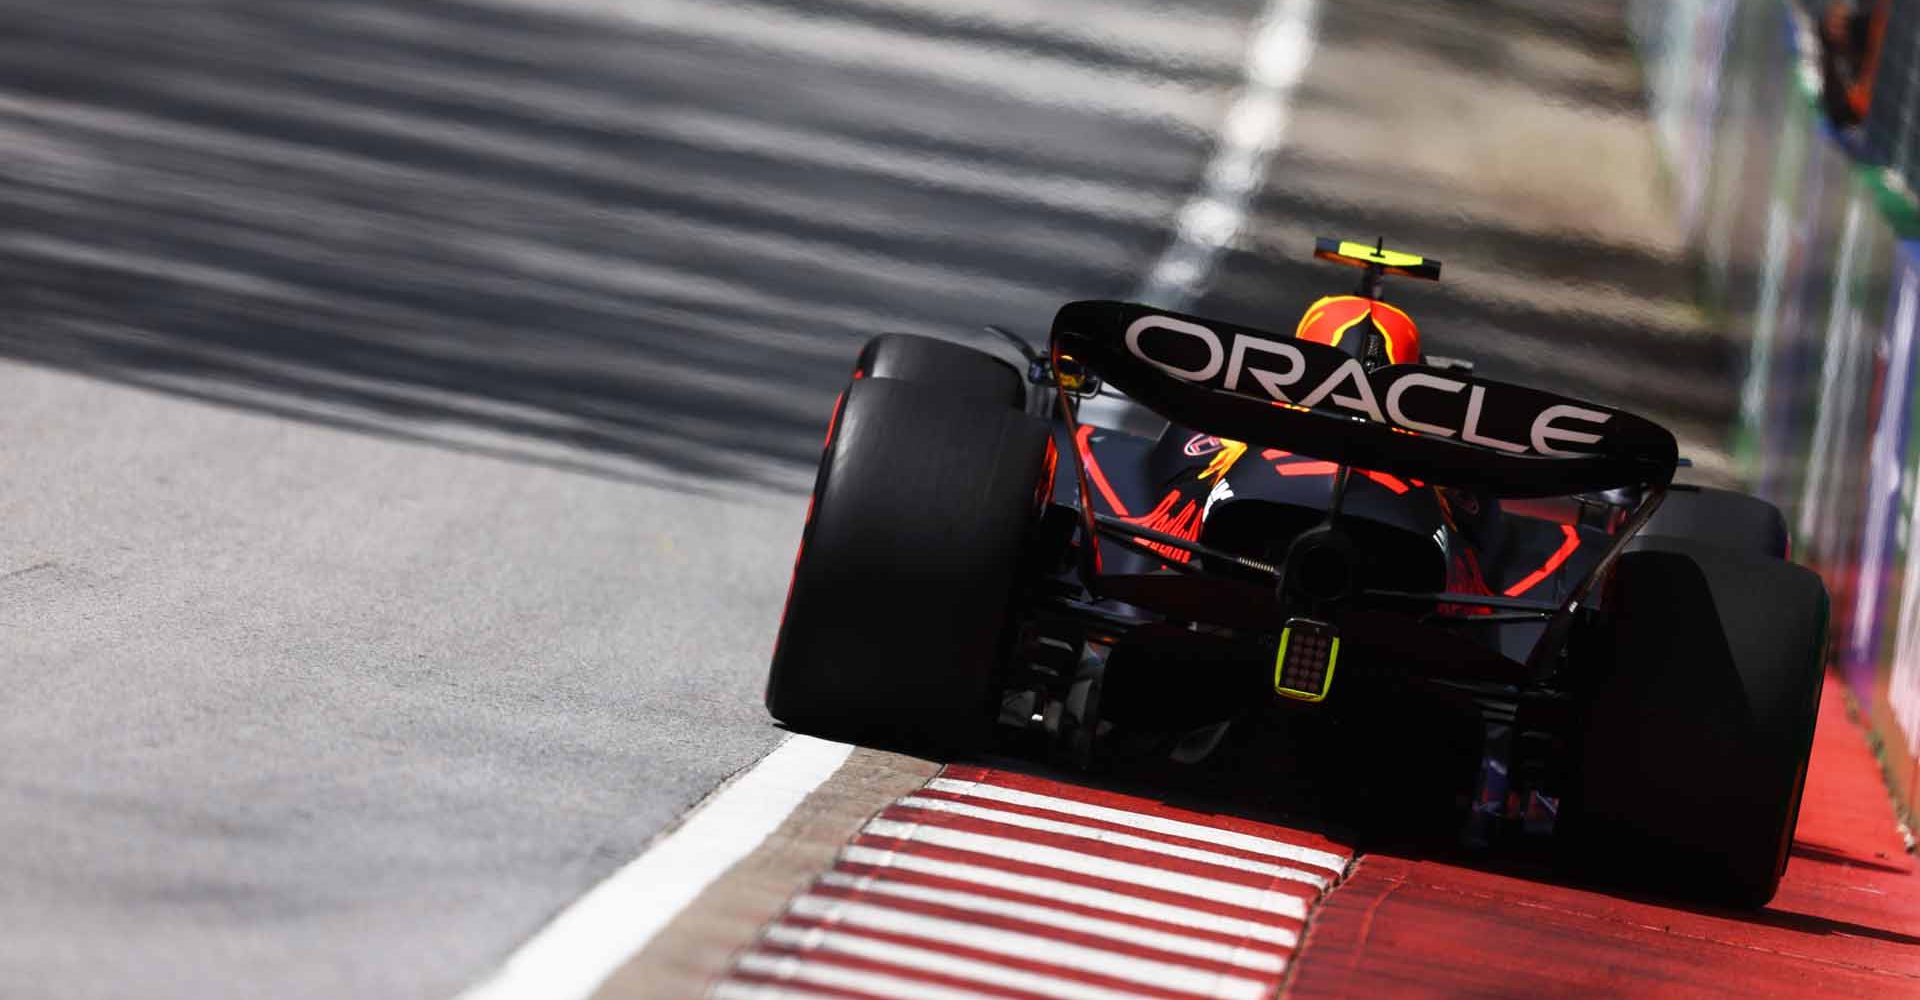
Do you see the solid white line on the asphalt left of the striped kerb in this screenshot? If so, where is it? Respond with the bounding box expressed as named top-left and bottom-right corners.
top-left (461, 735), bottom-right (852, 1000)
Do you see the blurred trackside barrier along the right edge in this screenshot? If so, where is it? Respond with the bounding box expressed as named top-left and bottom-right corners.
top-left (1630, 0), bottom-right (1920, 816)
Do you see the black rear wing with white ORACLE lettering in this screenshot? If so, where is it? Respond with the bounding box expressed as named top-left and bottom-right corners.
top-left (1050, 301), bottom-right (1678, 497)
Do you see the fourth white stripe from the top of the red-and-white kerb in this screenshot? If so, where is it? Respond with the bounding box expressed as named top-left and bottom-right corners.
top-left (841, 845), bottom-right (1308, 928)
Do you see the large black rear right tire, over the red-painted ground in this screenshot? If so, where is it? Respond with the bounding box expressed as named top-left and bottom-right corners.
top-left (1559, 537), bottom-right (1828, 906)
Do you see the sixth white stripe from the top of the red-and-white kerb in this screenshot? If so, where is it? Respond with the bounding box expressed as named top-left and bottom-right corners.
top-left (787, 896), bottom-right (1267, 1000)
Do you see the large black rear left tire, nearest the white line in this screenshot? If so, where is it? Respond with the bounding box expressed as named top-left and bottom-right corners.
top-left (766, 376), bottom-right (1052, 752)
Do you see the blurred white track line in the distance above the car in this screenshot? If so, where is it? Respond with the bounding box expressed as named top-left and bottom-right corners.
top-left (1133, 0), bottom-right (1319, 309)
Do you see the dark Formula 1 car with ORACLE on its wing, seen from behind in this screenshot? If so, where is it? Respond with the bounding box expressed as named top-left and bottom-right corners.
top-left (766, 240), bottom-right (1828, 906)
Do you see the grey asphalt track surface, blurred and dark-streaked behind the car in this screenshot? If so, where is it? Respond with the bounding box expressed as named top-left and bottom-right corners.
top-left (0, 0), bottom-right (1738, 998)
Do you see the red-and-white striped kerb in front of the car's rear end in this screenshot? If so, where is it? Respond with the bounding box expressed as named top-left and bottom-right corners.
top-left (712, 766), bottom-right (1352, 1000)
